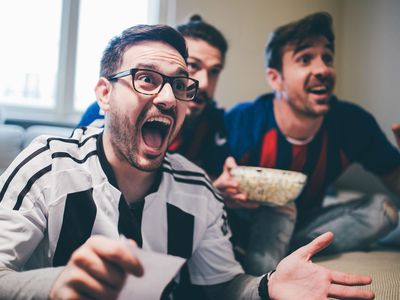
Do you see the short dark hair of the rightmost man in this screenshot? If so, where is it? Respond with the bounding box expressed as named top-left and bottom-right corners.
top-left (265, 12), bottom-right (335, 72)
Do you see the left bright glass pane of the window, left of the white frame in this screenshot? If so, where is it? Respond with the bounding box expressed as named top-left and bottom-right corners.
top-left (0, 0), bottom-right (61, 108)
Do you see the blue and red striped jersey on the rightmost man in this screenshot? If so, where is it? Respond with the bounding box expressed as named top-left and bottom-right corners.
top-left (225, 94), bottom-right (400, 210)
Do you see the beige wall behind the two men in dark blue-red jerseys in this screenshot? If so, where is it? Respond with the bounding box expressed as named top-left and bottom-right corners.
top-left (167, 0), bottom-right (400, 144)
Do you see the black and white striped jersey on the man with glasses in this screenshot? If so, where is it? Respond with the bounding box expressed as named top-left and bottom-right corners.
top-left (0, 128), bottom-right (243, 285)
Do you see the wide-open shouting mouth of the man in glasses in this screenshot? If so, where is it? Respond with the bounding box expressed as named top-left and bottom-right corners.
top-left (142, 116), bottom-right (171, 149)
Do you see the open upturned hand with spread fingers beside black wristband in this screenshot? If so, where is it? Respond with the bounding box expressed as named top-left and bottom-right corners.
top-left (268, 232), bottom-right (374, 300)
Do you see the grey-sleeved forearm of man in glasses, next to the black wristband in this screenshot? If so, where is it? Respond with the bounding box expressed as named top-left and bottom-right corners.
top-left (204, 274), bottom-right (262, 300)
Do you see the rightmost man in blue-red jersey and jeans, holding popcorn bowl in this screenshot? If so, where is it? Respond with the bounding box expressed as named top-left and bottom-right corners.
top-left (222, 13), bottom-right (400, 274)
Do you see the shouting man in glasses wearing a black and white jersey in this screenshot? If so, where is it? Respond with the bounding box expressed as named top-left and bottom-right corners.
top-left (0, 25), bottom-right (374, 300)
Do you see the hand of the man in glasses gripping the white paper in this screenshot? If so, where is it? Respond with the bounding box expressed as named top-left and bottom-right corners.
top-left (49, 236), bottom-right (143, 299)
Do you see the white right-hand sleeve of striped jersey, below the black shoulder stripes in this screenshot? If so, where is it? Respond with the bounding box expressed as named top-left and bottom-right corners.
top-left (188, 196), bottom-right (243, 285)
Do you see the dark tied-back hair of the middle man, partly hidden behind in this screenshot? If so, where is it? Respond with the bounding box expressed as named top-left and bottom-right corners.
top-left (177, 14), bottom-right (228, 62)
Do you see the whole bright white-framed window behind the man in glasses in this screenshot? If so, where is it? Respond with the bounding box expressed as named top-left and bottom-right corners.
top-left (0, 0), bottom-right (159, 122)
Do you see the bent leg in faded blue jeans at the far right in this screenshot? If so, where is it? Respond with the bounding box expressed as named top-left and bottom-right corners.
top-left (291, 195), bottom-right (398, 254)
